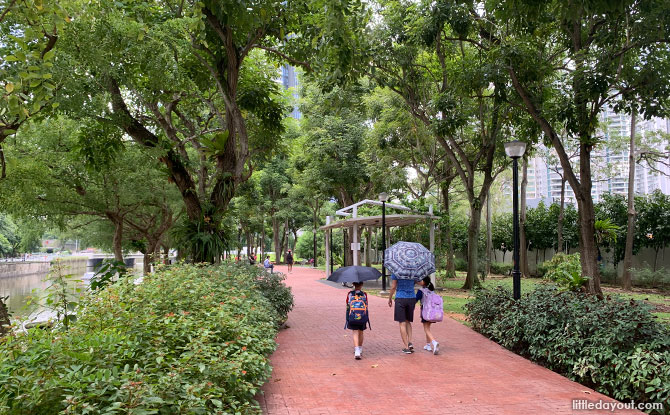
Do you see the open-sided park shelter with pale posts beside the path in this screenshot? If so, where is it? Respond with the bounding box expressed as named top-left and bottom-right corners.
top-left (320, 199), bottom-right (439, 278)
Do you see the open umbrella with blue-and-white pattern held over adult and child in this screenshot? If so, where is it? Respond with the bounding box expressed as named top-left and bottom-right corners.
top-left (384, 241), bottom-right (435, 281)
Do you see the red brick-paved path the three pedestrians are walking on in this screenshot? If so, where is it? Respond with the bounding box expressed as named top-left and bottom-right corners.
top-left (257, 266), bottom-right (642, 415)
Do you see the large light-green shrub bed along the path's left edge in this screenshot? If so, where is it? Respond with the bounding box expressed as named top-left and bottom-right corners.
top-left (0, 265), bottom-right (288, 414)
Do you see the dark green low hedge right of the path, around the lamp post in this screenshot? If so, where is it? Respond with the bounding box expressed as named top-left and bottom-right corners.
top-left (466, 286), bottom-right (670, 407)
